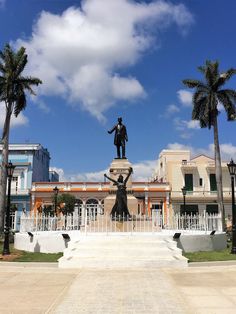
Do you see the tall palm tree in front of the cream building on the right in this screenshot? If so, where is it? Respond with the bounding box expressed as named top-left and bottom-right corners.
top-left (183, 60), bottom-right (236, 230)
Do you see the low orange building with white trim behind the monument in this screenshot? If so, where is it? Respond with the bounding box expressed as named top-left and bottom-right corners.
top-left (31, 182), bottom-right (170, 222)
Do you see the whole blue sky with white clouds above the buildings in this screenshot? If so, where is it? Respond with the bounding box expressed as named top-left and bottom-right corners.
top-left (0, 0), bottom-right (236, 180)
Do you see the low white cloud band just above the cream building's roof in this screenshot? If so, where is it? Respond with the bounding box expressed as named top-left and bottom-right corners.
top-left (167, 143), bottom-right (236, 161)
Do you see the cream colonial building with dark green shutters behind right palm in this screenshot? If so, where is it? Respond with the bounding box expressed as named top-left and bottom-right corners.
top-left (155, 150), bottom-right (232, 217)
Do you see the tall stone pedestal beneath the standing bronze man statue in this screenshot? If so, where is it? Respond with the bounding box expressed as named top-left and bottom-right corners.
top-left (104, 159), bottom-right (138, 215)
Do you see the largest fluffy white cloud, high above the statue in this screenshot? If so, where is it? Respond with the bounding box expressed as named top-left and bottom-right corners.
top-left (16, 0), bottom-right (193, 120)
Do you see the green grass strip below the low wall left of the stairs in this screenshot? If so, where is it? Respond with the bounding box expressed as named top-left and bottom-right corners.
top-left (0, 243), bottom-right (63, 263)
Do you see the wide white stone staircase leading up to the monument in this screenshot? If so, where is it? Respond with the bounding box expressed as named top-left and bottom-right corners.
top-left (59, 233), bottom-right (188, 269)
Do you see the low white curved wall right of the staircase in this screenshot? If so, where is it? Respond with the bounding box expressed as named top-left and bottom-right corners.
top-left (176, 233), bottom-right (227, 252)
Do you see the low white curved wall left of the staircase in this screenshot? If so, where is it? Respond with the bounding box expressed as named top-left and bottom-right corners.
top-left (14, 231), bottom-right (80, 253)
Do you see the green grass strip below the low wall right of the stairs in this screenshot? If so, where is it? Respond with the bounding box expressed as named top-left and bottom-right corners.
top-left (183, 245), bottom-right (236, 263)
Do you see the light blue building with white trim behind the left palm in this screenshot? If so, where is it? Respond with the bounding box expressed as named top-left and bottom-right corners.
top-left (0, 144), bottom-right (50, 224)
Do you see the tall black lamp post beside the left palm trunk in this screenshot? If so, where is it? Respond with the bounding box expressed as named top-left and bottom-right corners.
top-left (2, 162), bottom-right (15, 255)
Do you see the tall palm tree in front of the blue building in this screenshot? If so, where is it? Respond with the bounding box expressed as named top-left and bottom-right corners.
top-left (0, 44), bottom-right (42, 232)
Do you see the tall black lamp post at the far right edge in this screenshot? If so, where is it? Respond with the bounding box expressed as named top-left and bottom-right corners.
top-left (227, 159), bottom-right (236, 254)
